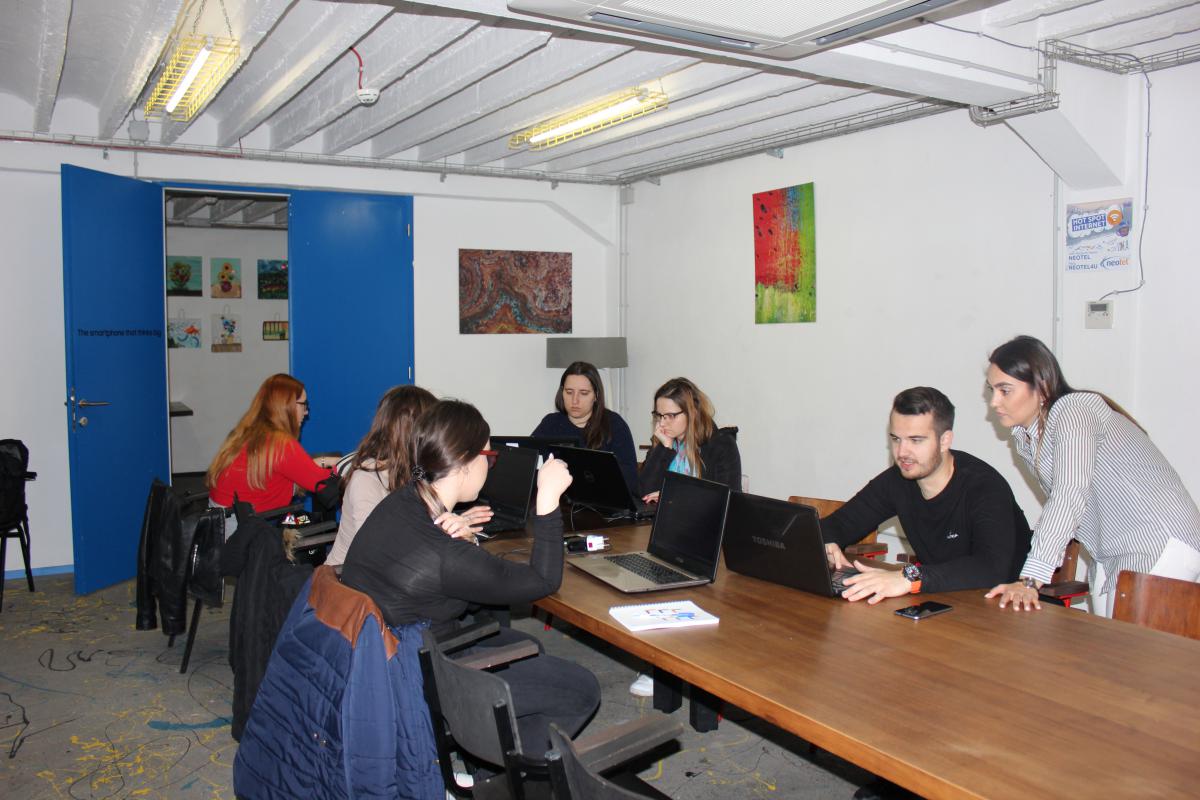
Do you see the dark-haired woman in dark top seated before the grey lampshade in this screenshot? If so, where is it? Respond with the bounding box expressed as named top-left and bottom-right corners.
top-left (532, 361), bottom-right (637, 492)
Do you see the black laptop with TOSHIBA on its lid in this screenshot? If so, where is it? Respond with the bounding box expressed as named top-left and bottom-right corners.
top-left (725, 493), bottom-right (858, 597)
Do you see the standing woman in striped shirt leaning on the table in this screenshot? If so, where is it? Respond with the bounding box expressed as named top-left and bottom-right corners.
top-left (988, 336), bottom-right (1200, 615)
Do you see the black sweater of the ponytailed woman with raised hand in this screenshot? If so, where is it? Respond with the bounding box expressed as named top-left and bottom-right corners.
top-left (342, 486), bottom-right (563, 632)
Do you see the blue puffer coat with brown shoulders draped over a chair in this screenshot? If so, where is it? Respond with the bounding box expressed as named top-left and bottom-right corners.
top-left (233, 566), bottom-right (445, 800)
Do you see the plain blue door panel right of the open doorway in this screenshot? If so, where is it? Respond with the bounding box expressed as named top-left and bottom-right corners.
top-left (288, 191), bottom-right (413, 453)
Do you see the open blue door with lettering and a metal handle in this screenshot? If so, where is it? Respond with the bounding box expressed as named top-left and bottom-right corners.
top-left (62, 164), bottom-right (170, 594)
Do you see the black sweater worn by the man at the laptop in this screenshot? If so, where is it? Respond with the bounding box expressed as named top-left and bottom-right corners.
top-left (821, 450), bottom-right (1031, 591)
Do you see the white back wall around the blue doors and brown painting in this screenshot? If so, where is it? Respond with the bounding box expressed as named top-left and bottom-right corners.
top-left (0, 143), bottom-right (617, 569)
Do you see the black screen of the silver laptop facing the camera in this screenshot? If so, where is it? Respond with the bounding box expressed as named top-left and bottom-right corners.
top-left (647, 473), bottom-right (730, 578)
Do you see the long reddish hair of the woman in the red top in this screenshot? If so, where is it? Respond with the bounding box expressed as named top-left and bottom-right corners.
top-left (204, 372), bottom-right (304, 489)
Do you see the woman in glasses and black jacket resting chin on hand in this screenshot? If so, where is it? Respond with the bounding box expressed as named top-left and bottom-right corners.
top-left (638, 378), bottom-right (742, 503)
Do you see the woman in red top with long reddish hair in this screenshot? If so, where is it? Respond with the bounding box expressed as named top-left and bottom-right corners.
top-left (205, 373), bottom-right (337, 511)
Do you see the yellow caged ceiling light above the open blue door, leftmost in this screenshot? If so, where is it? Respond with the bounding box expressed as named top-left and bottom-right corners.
top-left (145, 34), bottom-right (241, 122)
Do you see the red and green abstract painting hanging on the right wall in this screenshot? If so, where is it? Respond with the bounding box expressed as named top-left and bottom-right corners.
top-left (754, 184), bottom-right (817, 324)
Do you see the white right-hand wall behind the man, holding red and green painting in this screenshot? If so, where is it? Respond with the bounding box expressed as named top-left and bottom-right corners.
top-left (629, 112), bottom-right (1052, 551)
